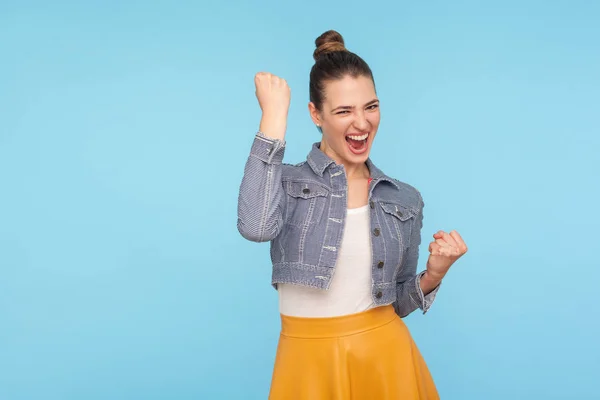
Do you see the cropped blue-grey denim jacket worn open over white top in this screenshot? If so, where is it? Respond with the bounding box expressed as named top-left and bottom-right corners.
top-left (237, 132), bottom-right (439, 317)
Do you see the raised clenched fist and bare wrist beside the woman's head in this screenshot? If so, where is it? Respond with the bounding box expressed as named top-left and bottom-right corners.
top-left (254, 72), bottom-right (291, 140)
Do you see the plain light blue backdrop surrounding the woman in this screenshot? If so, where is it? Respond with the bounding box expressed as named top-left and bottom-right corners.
top-left (0, 0), bottom-right (600, 400)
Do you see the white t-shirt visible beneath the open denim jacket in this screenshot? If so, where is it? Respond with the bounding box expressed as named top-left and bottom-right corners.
top-left (277, 205), bottom-right (373, 317)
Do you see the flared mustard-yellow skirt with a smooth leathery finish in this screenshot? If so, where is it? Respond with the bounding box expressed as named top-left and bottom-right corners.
top-left (269, 305), bottom-right (439, 400)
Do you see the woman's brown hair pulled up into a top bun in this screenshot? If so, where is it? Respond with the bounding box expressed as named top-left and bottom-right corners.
top-left (309, 30), bottom-right (375, 111)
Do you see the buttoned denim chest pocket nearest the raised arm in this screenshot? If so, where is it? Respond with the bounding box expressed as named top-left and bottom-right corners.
top-left (284, 181), bottom-right (329, 226)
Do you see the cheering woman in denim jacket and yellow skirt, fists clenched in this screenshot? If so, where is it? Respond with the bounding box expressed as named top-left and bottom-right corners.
top-left (238, 31), bottom-right (467, 400)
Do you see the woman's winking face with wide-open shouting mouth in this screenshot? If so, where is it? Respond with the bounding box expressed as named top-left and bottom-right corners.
top-left (309, 75), bottom-right (380, 165)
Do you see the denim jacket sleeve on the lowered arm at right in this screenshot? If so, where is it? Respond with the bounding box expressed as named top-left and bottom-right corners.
top-left (396, 192), bottom-right (440, 317)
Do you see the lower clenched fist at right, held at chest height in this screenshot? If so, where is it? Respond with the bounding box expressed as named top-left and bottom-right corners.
top-left (427, 231), bottom-right (468, 281)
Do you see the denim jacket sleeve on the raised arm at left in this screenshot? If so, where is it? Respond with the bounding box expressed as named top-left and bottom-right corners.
top-left (237, 132), bottom-right (285, 242)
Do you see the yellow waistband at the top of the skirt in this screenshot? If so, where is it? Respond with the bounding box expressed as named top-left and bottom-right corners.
top-left (281, 304), bottom-right (398, 339)
